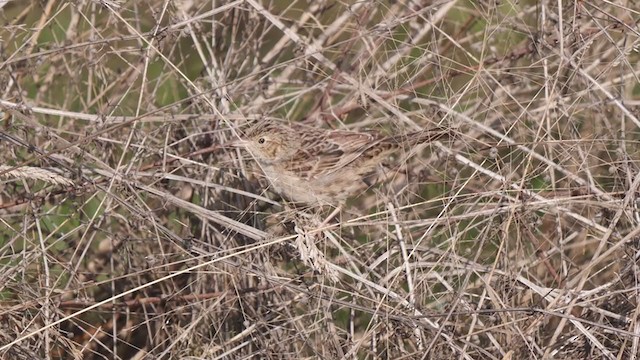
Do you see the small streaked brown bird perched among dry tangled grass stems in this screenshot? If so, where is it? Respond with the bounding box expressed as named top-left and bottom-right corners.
top-left (234, 119), bottom-right (450, 205)
